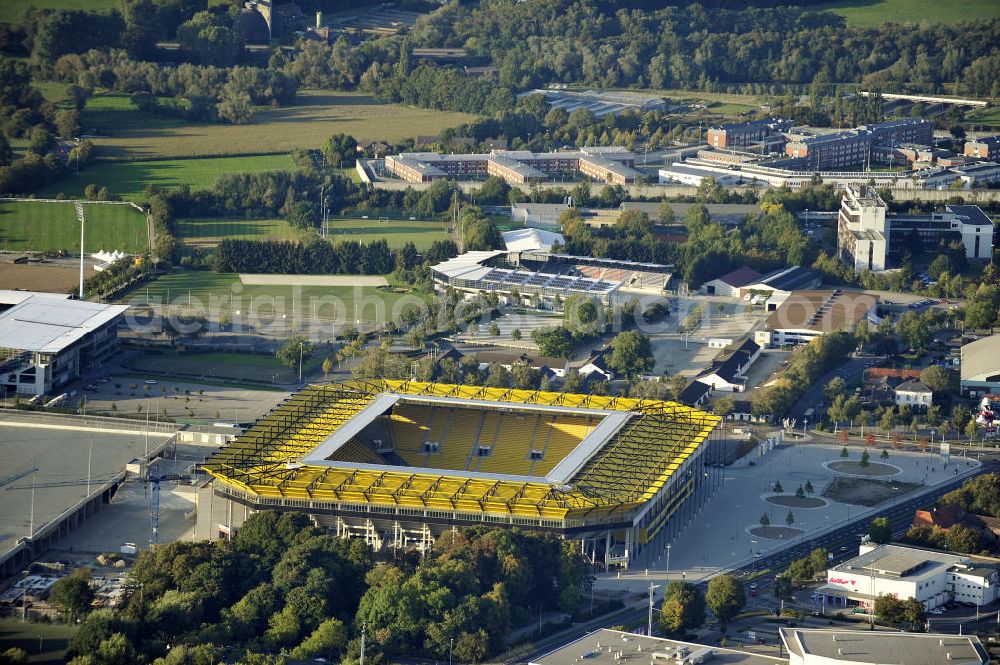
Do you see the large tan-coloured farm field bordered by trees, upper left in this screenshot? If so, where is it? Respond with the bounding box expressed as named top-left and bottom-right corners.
top-left (83, 90), bottom-right (475, 159)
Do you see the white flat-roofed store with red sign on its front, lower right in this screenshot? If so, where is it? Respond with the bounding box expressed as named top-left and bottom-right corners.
top-left (816, 544), bottom-right (1000, 609)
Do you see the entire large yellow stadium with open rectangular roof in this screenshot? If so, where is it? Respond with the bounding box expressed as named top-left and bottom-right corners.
top-left (204, 381), bottom-right (719, 567)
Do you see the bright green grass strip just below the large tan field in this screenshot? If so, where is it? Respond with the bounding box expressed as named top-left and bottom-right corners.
top-left (40, 155), bottom-right (295, 202)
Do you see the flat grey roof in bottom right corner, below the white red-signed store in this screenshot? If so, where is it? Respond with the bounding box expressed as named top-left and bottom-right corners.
top-left (779, 628), bottom-right (989, 665)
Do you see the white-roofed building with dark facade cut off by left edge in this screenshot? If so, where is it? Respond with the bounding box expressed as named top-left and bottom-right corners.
top-left (0, 291), bottom-right (128, 395)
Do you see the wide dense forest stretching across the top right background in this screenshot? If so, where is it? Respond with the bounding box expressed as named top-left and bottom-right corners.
top-left (287, 0), bottom-right (1000, 114)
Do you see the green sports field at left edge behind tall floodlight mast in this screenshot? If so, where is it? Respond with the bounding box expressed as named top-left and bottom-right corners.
top-left (0, 201), bottom-right (149, 254)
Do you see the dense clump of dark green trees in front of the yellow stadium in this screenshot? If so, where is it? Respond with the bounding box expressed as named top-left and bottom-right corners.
top-left (58, 512), bottom-right (592, 665)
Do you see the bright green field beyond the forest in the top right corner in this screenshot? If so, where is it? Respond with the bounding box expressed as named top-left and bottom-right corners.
top-left (809, 0), bottom-right (1000, 27)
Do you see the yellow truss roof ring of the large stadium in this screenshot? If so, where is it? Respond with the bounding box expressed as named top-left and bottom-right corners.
top-left (204, 380), bottom-right (720, 521)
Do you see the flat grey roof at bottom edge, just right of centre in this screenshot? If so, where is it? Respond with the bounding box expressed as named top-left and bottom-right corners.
top-left (529, 628), bottom-right (788, 665)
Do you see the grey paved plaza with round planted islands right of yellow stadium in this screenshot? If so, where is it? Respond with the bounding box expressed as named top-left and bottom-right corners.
top-left (598, 443), bottom-right (979, 588)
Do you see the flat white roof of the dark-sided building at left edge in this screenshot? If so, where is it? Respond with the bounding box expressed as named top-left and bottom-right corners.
top-left (0, 291), bottom-right (128, 353)
